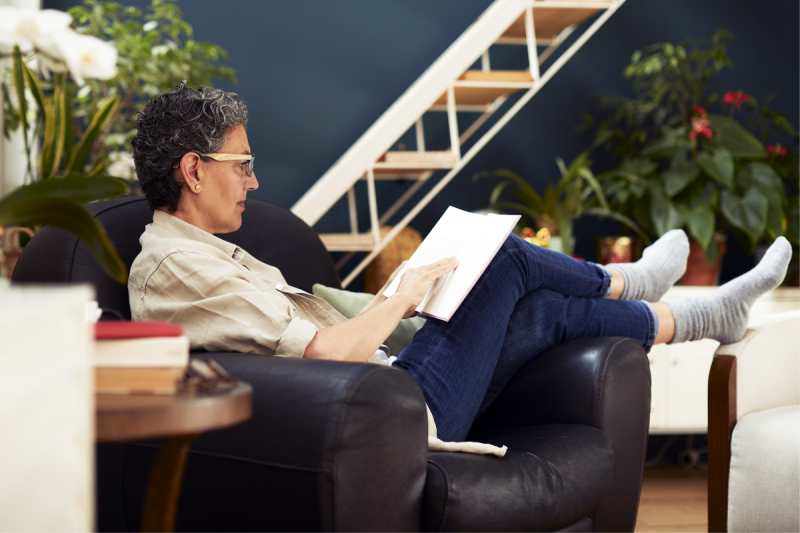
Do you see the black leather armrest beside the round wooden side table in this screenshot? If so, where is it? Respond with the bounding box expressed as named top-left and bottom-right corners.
top-left (179, 353), bottom-right (428, 532)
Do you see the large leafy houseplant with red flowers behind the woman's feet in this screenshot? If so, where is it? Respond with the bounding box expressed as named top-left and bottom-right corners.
top-left (588, 30), bottom-right (800, 264)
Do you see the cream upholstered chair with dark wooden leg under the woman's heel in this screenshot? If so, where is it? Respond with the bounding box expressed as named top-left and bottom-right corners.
top-left (708, 311), bottom-right (800, 533)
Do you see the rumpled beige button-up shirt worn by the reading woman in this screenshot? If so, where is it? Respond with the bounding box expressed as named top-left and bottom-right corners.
top-left (128, 211), bottom-right (352, 357)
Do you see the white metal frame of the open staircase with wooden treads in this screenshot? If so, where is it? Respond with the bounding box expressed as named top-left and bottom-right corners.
top-left (292, 0), bottom-right (624, 287)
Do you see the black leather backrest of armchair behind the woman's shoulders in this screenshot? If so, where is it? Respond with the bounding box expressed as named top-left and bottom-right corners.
top-left (11, 197), bottom-right (341, 318)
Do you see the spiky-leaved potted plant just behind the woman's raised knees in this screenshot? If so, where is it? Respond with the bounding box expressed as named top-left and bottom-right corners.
top-left (473, 143), bottom-right (650, 255)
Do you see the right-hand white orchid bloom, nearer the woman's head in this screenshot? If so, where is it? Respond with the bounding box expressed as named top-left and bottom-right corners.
top-left (53, 30), bottom-right (117, 85)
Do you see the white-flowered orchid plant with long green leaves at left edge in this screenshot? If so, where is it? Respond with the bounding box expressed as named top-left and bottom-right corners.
top-left (0, 7), bottom-right (128, 283)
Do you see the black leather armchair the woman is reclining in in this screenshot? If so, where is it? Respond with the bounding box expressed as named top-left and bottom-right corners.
top-left (12, 198), bottom-right (650, 533)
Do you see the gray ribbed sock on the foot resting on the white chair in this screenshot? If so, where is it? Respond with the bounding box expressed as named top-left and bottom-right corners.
top-left (664, 237), bottom-right (792, 344)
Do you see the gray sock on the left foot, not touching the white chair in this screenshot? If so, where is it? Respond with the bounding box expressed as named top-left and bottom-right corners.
top-left (604, 229), bottom-right (689, 302)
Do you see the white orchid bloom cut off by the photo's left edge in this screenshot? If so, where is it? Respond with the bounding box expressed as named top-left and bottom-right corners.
top-left (0, 6), bottom-right (72, 54)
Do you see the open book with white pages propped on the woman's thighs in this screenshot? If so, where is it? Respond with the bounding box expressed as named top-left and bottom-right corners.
top-left (383, 207), bottom-right (520, 322)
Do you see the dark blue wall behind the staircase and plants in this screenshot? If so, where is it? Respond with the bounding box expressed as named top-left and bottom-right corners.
top-left (50, 0), bottom-right (800, 277)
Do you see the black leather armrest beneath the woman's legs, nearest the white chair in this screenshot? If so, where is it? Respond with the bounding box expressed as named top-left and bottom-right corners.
top-left (470, 337), bottom-right (650, 531)
